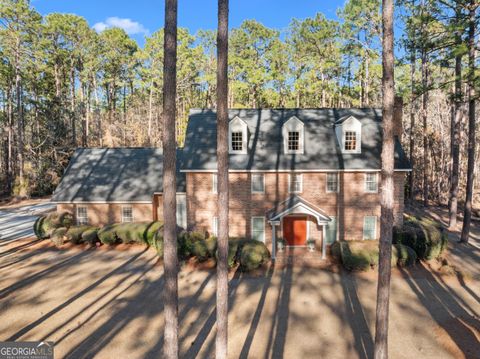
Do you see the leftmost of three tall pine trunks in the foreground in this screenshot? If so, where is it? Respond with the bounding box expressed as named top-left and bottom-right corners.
top-left (163, 0), bottom-right (178, 359)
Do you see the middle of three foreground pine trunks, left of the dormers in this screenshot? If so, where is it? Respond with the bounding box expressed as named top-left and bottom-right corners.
top-left (215, 0), bottom-right (229, 359)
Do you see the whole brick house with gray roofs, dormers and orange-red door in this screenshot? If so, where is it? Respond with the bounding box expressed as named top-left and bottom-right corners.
top-left (52, 101), bottom-right (411, 255)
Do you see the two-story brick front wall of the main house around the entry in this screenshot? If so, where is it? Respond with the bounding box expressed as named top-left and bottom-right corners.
top-left (187, 172), bottom-right (404, 248)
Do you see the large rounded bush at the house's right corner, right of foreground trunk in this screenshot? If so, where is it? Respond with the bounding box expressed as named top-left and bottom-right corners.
top-left (393, 216), bottom-right (448, 260)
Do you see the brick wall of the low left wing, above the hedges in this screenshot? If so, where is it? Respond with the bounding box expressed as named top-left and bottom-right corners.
top-left (57, 203), bottom-right (153, 226)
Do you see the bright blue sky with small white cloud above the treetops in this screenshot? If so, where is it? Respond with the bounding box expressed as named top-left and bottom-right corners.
top-left (32, 0), bottom-right (345, 45)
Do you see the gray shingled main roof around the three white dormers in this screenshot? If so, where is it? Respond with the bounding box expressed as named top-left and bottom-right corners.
top-left (182, 108), bottom-right (410, 171)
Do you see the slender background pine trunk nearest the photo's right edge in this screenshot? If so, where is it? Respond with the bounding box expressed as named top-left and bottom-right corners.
top-left (449, 6), bottom-right (463, 230)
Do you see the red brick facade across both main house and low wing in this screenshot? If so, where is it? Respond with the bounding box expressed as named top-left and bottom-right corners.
top-left (58, 172), bottom-right (405, 253)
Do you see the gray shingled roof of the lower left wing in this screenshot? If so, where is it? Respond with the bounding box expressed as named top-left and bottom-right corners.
top-left (52, 148), bottom-right (186, 202)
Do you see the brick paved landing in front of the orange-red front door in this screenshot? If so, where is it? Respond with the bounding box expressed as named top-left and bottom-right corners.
top-left (275, 246), bottom-right (331, 268)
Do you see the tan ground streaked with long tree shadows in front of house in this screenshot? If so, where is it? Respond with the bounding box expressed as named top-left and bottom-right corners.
top-left (0, 210), bottom-right (480, 359)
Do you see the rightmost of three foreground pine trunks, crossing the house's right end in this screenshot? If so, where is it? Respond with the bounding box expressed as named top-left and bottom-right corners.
top-left (375, 0), bottom-right (395, 359)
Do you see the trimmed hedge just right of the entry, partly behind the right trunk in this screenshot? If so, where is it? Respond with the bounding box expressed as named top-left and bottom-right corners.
top-left (332, 241), bottom-right (398, 271)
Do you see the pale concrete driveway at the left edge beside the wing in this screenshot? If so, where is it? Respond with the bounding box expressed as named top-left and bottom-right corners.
top-left (0, 202), bottom-right (55, 243)
